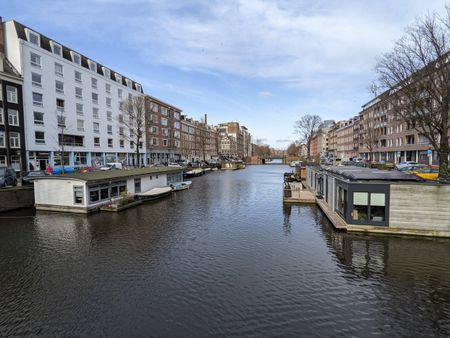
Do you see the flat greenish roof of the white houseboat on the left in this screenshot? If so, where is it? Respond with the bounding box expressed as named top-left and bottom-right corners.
top-left (39, 167), bottom-right (183, 182)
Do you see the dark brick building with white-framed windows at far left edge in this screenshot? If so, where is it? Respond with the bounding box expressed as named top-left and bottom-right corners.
top-left (0, 53), bottom-right (26, 170)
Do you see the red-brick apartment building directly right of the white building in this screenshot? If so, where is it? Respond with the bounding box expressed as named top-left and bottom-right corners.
top-left (145, 95), bottom-right (182, 164)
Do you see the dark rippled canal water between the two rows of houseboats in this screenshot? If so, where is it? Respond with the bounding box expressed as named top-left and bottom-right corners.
top-left (0, 165), bottom-right (450, 337)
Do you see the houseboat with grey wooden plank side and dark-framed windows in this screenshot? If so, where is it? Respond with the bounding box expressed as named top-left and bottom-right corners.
top-left (305, 166), bottom-right (450, 237)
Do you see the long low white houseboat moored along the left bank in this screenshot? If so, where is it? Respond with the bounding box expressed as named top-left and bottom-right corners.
top-left (34, 167), bottom-right (183, 213)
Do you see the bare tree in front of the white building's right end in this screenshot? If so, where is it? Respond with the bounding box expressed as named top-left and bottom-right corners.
top-left (119, 95), bottom-right (146, 167)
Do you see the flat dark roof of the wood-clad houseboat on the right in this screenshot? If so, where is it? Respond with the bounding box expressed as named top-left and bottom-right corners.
top-left (325, 166), bottom-right (423, 182)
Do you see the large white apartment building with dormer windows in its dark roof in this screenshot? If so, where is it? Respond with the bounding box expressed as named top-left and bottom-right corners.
top-left (1, 20), bottom-right (144, 169)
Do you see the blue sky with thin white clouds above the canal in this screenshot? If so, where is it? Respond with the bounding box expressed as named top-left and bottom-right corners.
top-left (0, 0), bottom-right (446, 149)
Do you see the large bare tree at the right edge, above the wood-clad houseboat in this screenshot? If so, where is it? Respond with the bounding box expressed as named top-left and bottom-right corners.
top-left (376, 7), bottom-right (450, 178)
